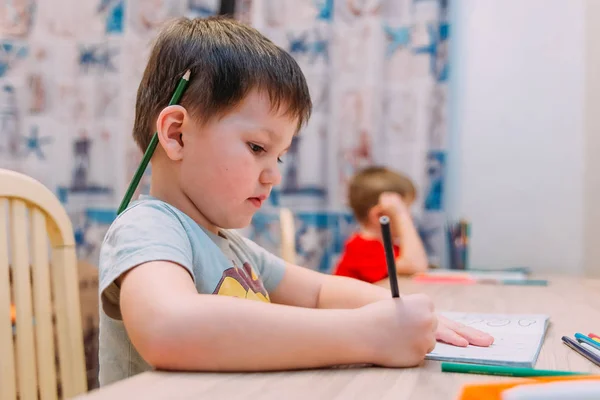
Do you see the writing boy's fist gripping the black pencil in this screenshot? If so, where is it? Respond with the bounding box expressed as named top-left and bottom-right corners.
top-left (360, 294), bottom-right (437, 367)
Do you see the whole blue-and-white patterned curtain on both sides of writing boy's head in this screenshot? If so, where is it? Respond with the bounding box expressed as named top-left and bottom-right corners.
top-left (0, 0), bottom-right (449, 272)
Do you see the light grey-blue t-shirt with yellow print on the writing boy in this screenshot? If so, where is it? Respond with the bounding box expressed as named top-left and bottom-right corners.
top-left (99, 196), bottom-right (285, 386)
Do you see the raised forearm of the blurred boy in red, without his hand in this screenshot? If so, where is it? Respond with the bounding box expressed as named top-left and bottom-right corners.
top-left (393, 215), bottom-right (428, 274)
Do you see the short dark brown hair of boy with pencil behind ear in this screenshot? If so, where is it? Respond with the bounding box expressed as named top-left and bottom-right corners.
top-left (133, 17), bottom-right (312, 151)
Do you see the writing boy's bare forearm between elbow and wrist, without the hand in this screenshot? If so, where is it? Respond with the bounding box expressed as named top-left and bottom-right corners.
top-left (134, 295), bottom-right (378, 371)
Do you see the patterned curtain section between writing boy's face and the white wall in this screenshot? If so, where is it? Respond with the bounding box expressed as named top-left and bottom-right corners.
top-left (238, 0), bottom-right (449, 272)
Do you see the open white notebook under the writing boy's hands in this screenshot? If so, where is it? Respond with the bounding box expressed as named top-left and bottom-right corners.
top-left (426, 312), bottom-right (549, 368)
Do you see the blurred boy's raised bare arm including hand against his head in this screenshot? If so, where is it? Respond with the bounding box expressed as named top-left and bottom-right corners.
top-left (379, 193), bottom-right (429, 275)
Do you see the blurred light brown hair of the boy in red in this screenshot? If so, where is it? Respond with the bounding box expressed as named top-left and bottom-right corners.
top-left (348, 166), bottom-right (417, 222)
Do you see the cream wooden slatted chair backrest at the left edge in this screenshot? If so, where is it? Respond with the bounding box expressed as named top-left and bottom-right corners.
top-left (0, 169), bottom-right (87, 400)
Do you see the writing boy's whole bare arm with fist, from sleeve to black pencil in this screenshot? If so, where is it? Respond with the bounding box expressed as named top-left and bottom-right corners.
top-left (118, 261), bottom-right (435, 371)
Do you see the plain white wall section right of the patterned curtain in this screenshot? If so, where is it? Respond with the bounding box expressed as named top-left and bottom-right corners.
top-left (447, 0), bottom-right (585, 274)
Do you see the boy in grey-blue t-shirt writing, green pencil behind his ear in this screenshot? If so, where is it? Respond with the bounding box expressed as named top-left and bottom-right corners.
top-left (99, 18), bottom-right (493, 385)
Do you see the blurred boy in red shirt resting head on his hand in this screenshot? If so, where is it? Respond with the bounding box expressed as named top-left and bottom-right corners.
top-left (335, 167), bottom-right (428, 283)
